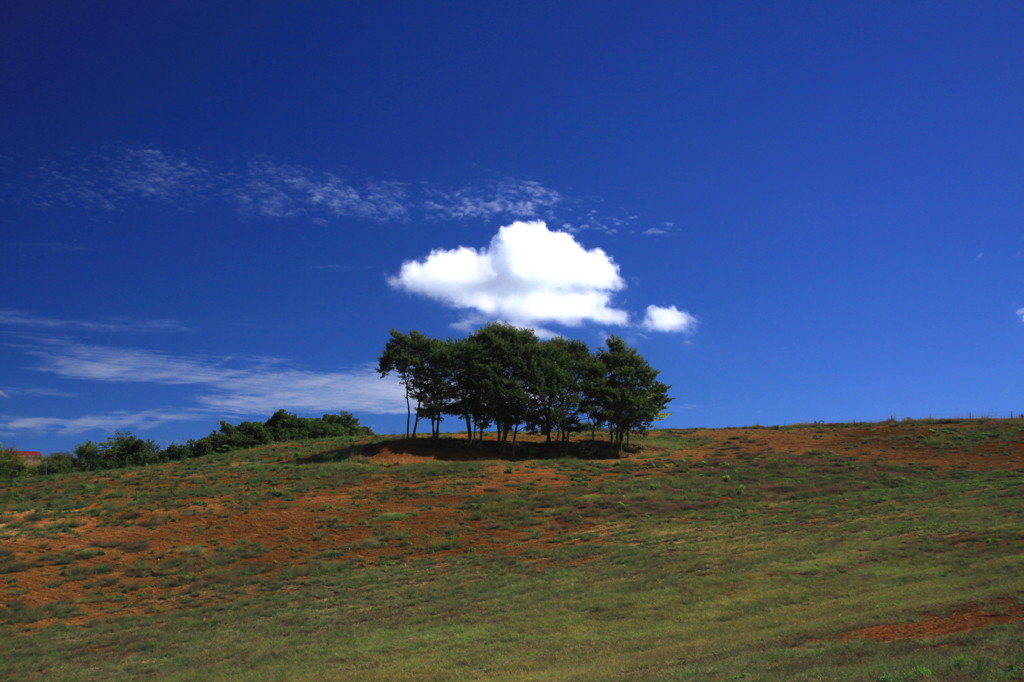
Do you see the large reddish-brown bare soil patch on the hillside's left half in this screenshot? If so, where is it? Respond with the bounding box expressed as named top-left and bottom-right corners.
top-left (0, 442), bottom-right (596, 629)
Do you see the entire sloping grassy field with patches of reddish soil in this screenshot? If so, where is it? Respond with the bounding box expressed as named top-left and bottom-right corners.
top-left (0, 420), bottom-right (1024, 680)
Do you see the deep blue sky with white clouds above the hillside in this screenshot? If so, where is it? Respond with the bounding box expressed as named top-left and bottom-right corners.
top-left (0, 0), bottom-right (1024, 452)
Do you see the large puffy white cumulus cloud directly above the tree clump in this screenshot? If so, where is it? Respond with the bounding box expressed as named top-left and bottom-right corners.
top-left (388, 221), bottom-right (629, 327)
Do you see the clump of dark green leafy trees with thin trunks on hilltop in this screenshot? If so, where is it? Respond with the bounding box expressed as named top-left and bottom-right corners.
top-left (378, 324), bottom-right (672, 449)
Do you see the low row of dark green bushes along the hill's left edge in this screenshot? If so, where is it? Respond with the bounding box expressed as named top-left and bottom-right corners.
top-left (0, 410), bottom-right (373, 478)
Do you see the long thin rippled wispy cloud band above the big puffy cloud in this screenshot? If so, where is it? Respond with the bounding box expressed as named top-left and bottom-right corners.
top-left (18, 146), bottom-right (663, 232)
